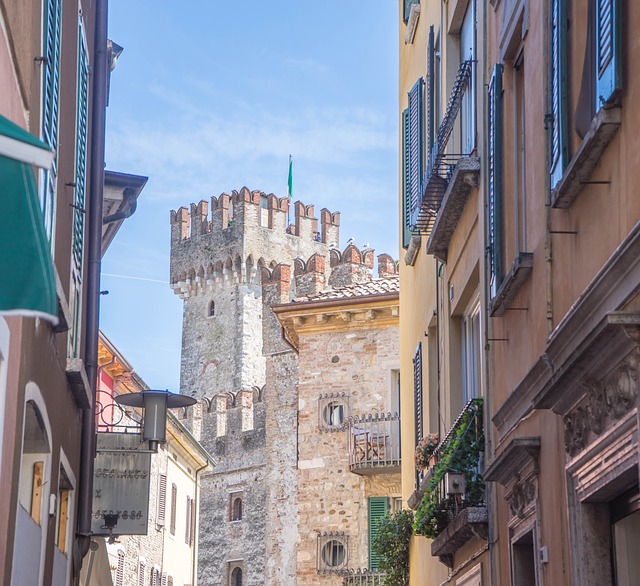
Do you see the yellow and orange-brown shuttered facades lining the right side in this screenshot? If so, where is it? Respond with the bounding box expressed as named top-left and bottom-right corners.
top-left (399, 0), bottom-right (640, 586)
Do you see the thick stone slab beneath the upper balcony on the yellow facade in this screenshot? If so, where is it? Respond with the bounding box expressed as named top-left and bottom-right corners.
top-left (427, 157), bottom-right (480, 262)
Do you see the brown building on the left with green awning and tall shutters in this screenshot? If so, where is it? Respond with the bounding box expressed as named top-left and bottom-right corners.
top-left (0, 0), bottom-right (145, 586)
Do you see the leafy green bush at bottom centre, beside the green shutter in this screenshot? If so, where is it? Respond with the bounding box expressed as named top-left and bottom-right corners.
top-left (371, 510), bottom-right (413, 586)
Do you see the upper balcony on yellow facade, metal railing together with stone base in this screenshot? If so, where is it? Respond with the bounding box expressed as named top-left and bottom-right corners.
top-left (412, 61), bottom-right (480, 235)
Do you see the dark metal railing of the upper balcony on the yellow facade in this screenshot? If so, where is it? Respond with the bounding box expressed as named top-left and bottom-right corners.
top-left (415, 59), bottom-right (473, 235)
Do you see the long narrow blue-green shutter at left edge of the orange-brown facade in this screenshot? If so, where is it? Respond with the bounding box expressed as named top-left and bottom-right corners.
top-left (487, 64), bottom-right (504, 299)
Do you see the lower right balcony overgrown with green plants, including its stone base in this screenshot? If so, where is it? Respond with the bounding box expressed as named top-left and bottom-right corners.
top-left (414, 399), bottom-right (488, 567)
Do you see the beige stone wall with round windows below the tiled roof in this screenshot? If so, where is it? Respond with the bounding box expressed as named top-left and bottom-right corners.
top-left (297, 321), bottom-right (401, 586)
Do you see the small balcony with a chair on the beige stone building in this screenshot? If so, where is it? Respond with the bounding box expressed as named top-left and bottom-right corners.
top-left (347, 413), bottom-right (400, 475)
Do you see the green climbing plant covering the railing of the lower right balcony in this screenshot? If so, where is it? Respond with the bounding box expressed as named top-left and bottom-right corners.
top-left (414, 399), bottom-right (484, 539)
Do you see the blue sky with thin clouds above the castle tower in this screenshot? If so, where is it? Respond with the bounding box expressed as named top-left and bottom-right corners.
top-left (101, 0), bottom-right (398, 391)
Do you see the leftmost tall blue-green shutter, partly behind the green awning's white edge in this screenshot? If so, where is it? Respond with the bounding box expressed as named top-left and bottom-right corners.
top-left (41, 0), bottom-right (62, 240)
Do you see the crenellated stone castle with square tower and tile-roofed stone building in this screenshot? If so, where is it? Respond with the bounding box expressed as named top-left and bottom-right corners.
top-left (171, 188), bottom-right (400, 586)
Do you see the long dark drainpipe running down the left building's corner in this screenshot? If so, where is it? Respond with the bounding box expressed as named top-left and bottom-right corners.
top-left (74, 0), bottom-right (108, 575)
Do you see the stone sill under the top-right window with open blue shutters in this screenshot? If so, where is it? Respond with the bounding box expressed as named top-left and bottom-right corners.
top-left (551, 108), bottom-right (622, 209)
